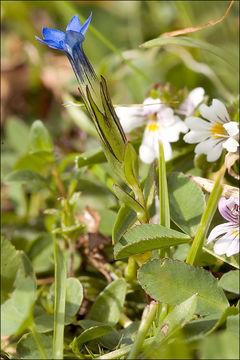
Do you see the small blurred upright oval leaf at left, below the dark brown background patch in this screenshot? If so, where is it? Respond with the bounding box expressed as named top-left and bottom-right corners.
top-left (28, 120), bottom-right (53, 154)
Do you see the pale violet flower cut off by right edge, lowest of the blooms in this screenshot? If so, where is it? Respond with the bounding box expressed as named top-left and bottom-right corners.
top-left (207, 196), bottom-right (239, 257)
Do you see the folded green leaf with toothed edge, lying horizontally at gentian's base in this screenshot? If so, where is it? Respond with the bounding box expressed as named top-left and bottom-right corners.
top-left (114, 224), bottom-right (191, 259)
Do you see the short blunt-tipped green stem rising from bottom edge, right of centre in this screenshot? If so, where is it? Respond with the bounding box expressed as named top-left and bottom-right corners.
top-left (128, 301), bottom-right (158, 359)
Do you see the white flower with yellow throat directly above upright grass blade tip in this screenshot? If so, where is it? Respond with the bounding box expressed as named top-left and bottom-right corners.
top-left (115, 97), bottom-right (188, 164)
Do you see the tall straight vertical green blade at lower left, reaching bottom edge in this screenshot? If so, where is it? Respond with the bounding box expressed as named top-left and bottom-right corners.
top-left (53, 235), bottom-right (66, 359)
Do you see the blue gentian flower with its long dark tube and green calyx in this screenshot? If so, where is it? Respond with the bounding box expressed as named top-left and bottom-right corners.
top-left (36, 13), bottom-right (127, 168)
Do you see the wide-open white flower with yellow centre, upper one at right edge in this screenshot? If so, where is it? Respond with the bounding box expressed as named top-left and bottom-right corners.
top-left (183, 99), bottom-right (239, 162)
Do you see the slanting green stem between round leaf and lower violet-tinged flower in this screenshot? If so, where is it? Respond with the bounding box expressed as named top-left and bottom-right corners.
top-left (186, 164), bottom-right (226, 265)
